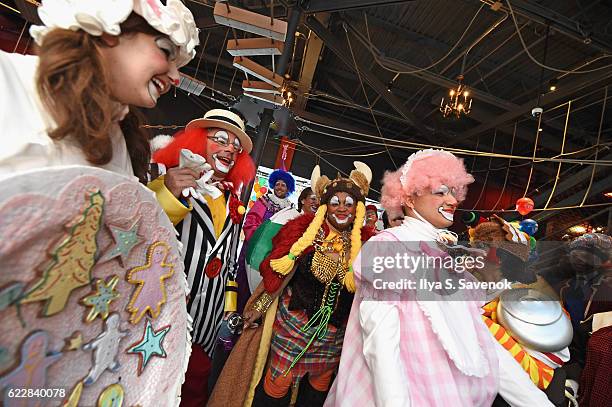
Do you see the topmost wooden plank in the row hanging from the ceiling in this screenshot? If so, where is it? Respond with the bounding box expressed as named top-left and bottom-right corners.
top-left (213, 2), bottom-right (287, 42)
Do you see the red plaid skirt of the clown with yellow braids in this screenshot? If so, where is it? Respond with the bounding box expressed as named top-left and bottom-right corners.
top-left (269, 287), bottom-right (346, 382)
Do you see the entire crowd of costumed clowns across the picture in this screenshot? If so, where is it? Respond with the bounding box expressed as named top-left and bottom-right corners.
top-left (0, 0), bottom-right (612, 407)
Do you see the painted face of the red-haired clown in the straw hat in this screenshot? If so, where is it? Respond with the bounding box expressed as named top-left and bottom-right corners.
top-left (206, 129), bottom-right (242, 179)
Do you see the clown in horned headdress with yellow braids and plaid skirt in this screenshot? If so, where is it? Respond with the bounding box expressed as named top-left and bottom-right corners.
top-left (209, 162), bottom-right (372, 406)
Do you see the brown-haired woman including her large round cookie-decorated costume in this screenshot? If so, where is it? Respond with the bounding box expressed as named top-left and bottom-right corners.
top-left (0, 0), bottom-right (198, 407)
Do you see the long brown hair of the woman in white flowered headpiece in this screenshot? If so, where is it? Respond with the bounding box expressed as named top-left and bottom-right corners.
top-left (36, 13), bottom-right (160, 182)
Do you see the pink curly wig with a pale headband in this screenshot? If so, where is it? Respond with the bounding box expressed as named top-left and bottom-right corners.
top-left (381, 149), bottom-right (474, 211)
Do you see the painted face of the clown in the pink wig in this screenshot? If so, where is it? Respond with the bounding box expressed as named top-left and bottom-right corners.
top-left (407, 185), bottom-right (458, 229)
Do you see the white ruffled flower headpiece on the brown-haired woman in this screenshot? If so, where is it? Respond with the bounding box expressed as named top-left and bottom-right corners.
top-left (30, 0), bottom-right (200, 67)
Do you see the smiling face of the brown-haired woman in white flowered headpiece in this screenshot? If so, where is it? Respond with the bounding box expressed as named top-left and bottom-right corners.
top-left (99, 32), bottom-right (179, 108)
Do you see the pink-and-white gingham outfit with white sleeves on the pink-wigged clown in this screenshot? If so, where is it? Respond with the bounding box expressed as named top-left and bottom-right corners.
top-left (325, 218), bottom-right (552, 407)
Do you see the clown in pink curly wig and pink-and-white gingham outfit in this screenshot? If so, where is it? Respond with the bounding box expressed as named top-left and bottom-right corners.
top-left (325, 150), bottom-right (551, 407)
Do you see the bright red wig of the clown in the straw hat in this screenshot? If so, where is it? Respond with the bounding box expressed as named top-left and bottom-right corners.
top-left (153, 128), bottom-right (255, 191)
